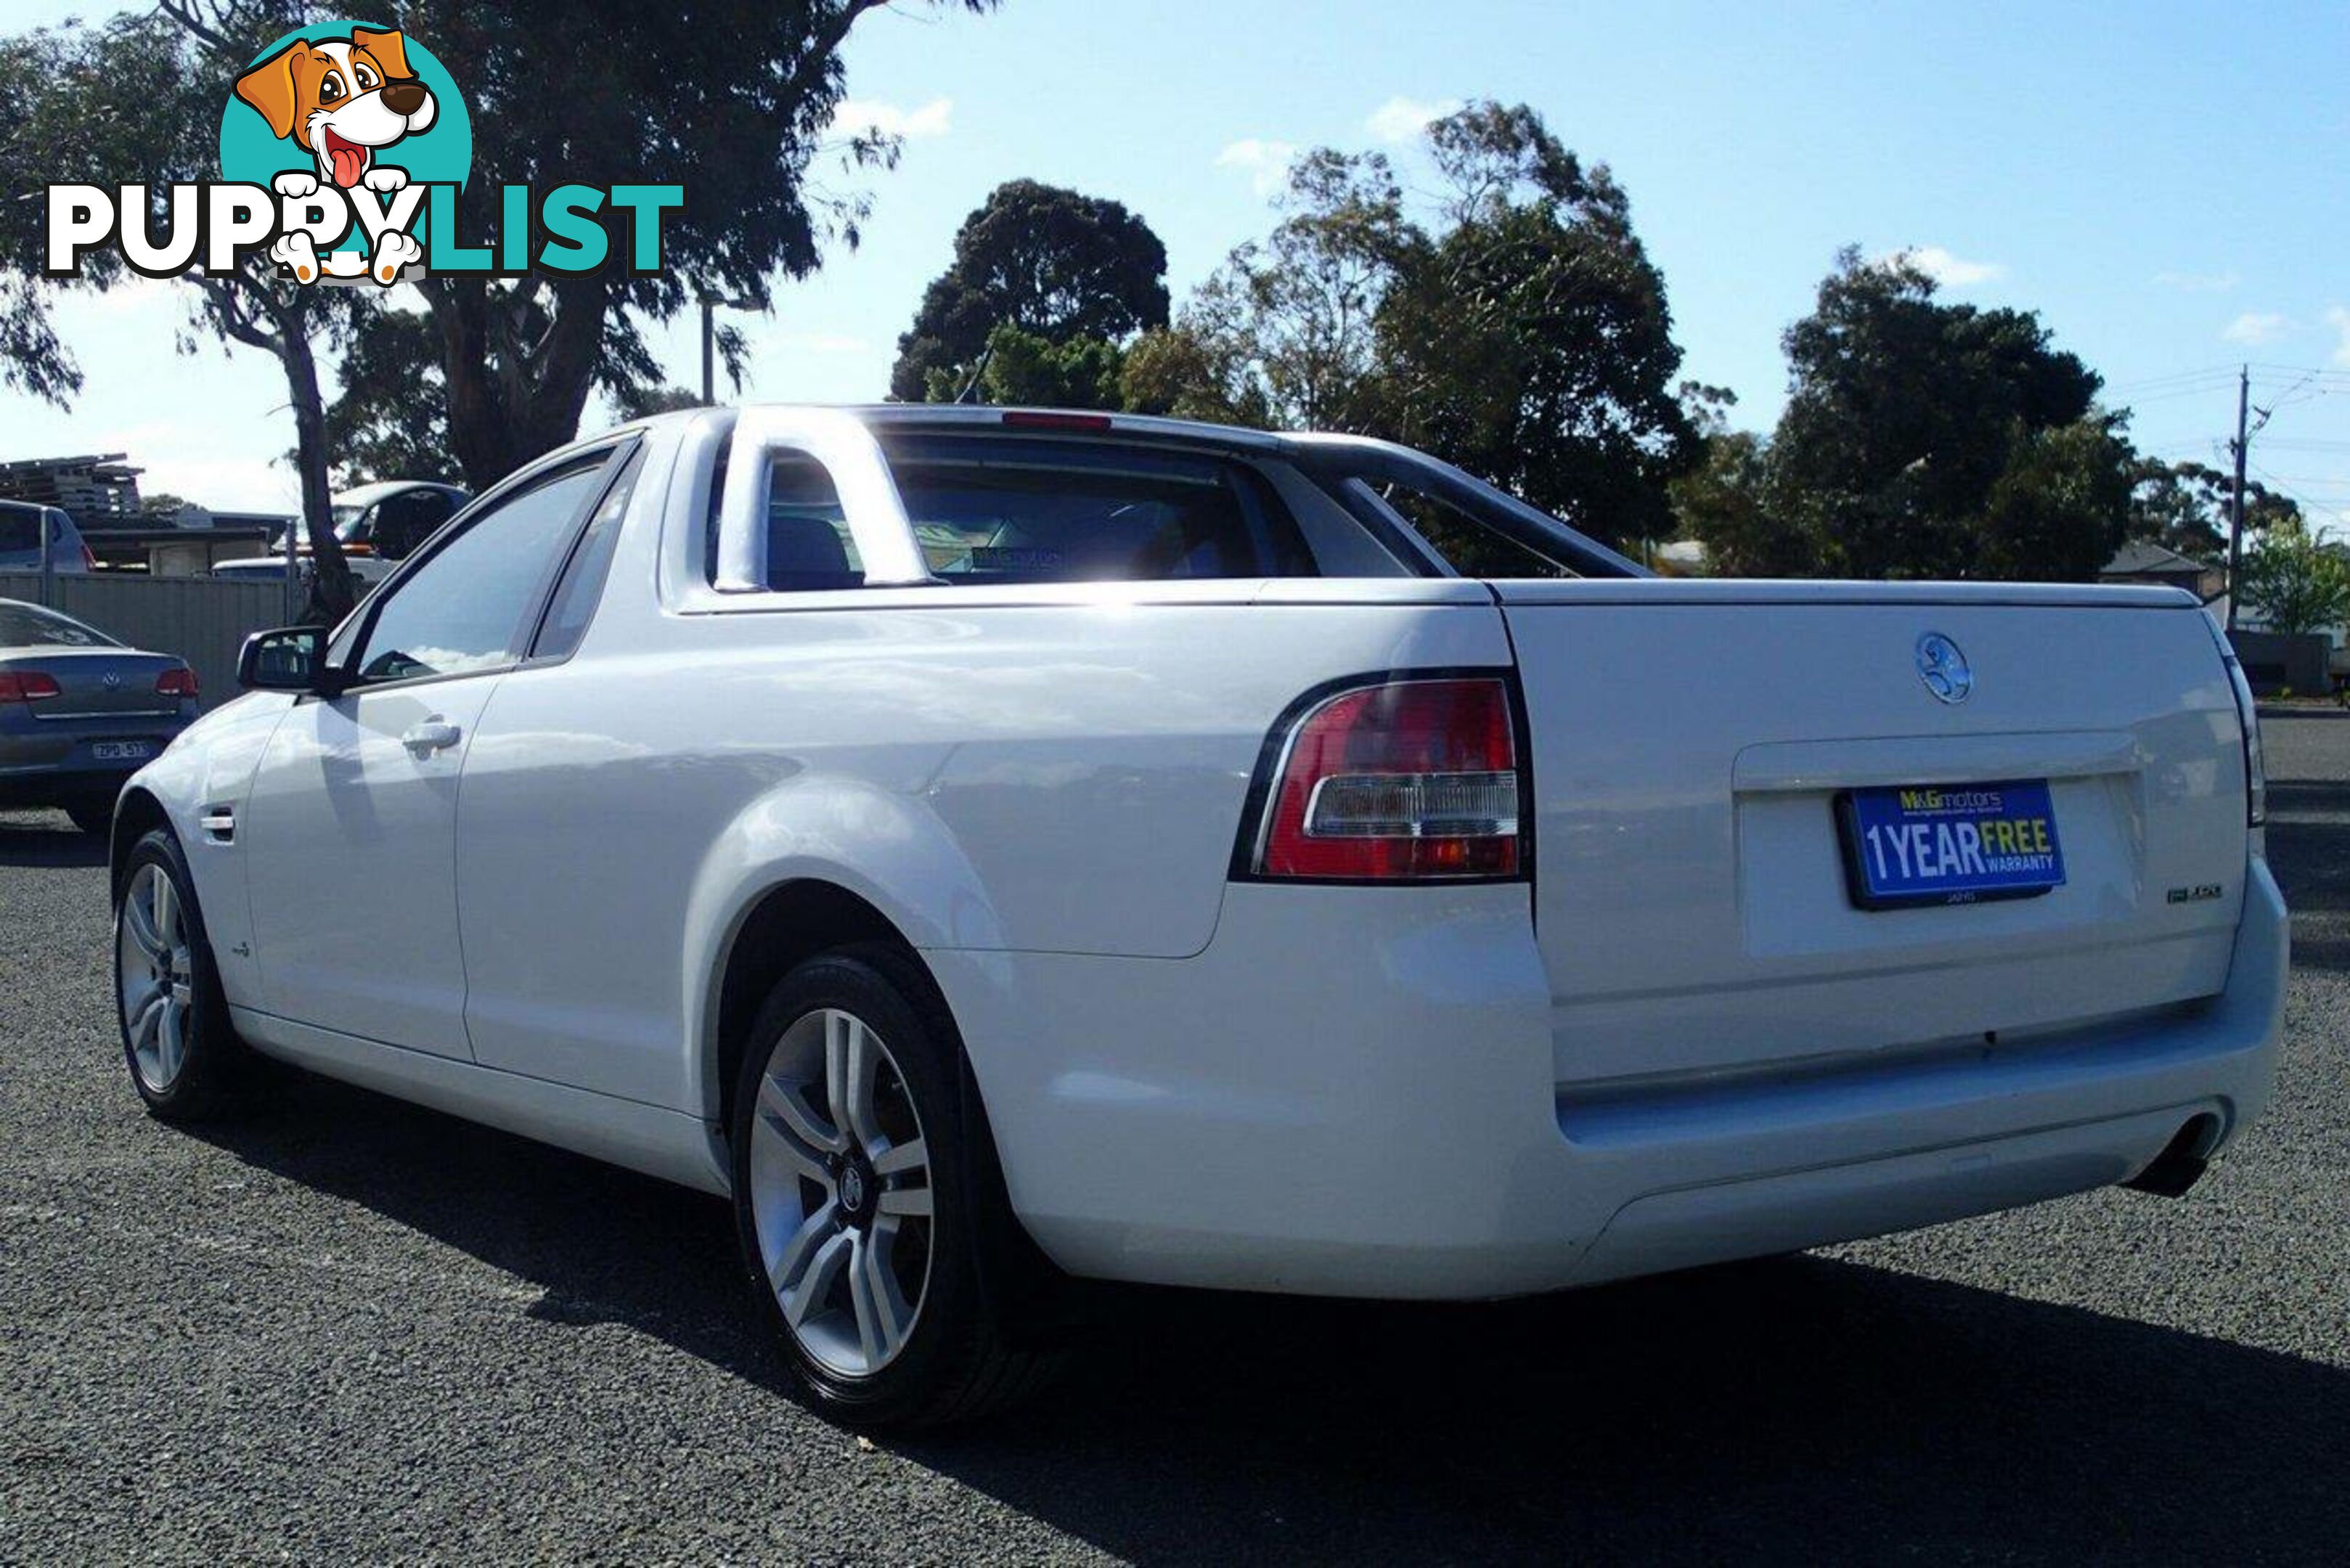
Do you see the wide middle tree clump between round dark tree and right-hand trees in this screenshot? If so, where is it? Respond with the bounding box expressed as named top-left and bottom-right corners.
top-left (1121, 103), bottom-right (1697, 543)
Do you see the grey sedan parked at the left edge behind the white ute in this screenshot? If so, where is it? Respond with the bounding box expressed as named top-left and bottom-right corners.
top-left (0, 600), bottom-right (195, 832)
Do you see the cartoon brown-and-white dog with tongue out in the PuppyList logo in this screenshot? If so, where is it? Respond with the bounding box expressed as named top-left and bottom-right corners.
top-left (237, 26), bottom-right (439, 285)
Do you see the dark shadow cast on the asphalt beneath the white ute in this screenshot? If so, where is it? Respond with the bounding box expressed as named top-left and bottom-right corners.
top-left (187, 1077), bottom-right (2350, 1561)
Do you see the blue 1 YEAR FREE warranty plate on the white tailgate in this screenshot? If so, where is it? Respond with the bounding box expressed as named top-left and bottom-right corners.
top-left (1837, 778), bottom-right (2063, 910)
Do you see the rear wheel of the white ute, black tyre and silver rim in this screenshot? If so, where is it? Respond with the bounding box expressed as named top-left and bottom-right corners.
top-left (728, 947), bottom-right (1050, 1427)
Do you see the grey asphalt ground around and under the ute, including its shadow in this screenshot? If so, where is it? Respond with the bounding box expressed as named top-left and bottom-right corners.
top-left (0, 712), bottom-right (2350, 1564)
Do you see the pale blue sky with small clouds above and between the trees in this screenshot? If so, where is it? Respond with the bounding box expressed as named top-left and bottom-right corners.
top-left (0, 0), bottom-right (2350, 526)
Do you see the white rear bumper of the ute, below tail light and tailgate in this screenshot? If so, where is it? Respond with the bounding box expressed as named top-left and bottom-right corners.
top-left (926, 860), bottom-right (2287, 1298)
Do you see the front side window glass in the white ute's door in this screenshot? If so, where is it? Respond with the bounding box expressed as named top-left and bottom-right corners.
top-left (355, 462), bottom-right (611, 682)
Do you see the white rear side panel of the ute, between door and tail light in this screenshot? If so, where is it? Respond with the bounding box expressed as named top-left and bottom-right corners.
top-left (458, 585), bottom-right (1509, 1110)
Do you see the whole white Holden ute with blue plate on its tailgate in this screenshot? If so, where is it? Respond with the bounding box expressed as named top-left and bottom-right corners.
top-left (113, 407), bottom-right (2287, 1422)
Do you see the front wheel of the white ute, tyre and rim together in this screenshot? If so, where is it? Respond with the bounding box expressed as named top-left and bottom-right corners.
top-left (115, 828), bottom-right (245, 1122)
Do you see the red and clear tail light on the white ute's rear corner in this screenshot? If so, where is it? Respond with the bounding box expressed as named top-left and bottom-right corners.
top-left (1239, 677), bottom-right (1525, 881)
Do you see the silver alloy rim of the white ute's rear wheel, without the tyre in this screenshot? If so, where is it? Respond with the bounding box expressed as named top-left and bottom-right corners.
top-left (750, 1008), bottom-right (933, 1378)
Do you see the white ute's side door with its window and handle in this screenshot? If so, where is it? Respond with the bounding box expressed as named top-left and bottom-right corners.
top-left (237, 446), bottom-right (613, 1058)
